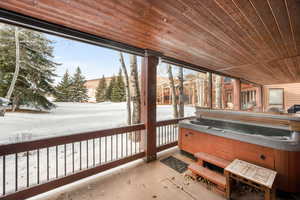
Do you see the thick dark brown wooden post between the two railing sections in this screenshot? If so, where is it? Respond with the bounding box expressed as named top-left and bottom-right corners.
top-left (141, 51), bottom-right (158, 162)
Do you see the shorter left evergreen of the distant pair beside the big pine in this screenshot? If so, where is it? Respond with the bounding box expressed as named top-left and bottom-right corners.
top-left (55, 70), bottom-right (72, 102)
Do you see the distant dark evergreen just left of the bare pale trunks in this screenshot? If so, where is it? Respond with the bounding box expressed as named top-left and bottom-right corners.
top-left (111, 70), bottom-right (125, 102)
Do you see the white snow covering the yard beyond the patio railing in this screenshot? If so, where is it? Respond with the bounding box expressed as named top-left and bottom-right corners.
top-left (0, 102), bottom-right (194, 197)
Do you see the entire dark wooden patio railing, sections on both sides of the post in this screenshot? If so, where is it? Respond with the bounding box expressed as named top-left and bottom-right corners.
top-left (0, 118), bottom-right (193, 200)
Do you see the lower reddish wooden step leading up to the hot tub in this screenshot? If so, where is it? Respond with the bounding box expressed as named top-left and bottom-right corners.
top-left (188, 163), bottom-right (226, 188)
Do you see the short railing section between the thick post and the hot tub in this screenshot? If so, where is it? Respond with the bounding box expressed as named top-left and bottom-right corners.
top-left (156, 117), bottom-right (194, 151)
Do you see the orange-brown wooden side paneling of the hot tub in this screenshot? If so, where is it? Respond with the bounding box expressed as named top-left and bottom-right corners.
top-left (178, 128), bottom-right (300, 192)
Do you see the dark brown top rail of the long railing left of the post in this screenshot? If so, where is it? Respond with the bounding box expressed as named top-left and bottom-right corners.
top-left (0, 124), bottom-right (145, 156)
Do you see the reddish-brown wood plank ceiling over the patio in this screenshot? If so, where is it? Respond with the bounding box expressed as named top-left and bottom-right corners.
top-left (0, 0), bottom-right (300, 84)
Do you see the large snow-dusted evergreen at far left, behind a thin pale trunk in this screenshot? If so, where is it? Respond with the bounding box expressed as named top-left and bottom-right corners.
top-left (0, 25), bottom-right (59, 109)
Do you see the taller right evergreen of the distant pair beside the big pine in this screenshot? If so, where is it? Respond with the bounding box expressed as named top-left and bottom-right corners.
top-left (70, 67), bottom-right (88, 102)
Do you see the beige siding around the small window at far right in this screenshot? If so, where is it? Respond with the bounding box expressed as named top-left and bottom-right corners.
top-left (263, 83), bottom-right (300, 110)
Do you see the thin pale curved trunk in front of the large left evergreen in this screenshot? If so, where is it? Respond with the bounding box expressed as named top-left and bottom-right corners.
top-left (3, 27), bottom-right (20, 115)
